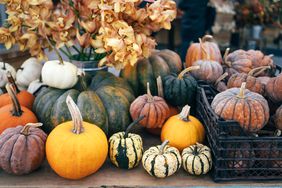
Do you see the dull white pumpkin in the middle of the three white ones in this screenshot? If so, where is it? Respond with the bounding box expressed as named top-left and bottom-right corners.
top-left (16, 57), bottom-right (42, 88)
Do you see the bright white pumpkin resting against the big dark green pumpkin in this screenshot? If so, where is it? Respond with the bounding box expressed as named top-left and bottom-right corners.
top-left (41, 60), bottom-right (79, 89)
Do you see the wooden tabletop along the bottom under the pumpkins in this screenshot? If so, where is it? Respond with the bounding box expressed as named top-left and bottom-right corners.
top-left (0, 128), bottom-right (282, 188)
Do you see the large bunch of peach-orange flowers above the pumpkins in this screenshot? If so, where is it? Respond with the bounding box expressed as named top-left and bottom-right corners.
top-left (0, 0), bottom-right (176, 69)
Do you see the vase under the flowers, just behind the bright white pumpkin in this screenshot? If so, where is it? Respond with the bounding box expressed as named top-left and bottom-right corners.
top-left (71, 60), bottom-right (108, 76)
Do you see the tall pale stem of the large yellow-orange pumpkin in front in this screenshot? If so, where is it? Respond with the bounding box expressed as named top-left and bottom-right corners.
top-left (66, 95), bottom-right (83, 134)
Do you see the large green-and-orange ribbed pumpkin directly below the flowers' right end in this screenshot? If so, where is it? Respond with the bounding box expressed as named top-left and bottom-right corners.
top-left (120, 50), bottom-right (182, 96)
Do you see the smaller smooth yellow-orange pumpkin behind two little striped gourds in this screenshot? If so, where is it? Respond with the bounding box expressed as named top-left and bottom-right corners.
top-left (161, 105), bottom-right (205, 151)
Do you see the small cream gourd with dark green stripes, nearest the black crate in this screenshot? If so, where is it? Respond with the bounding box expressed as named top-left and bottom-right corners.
top-left (182, 143), bottom-right (212, 175)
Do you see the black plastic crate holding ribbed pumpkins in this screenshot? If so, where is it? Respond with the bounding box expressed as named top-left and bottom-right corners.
top-left (197, 82), bottom-right (282, 181)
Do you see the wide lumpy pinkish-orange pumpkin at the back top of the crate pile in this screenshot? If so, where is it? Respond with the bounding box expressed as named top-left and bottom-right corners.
top-left (224, 48), bottom-right (275, 76)
